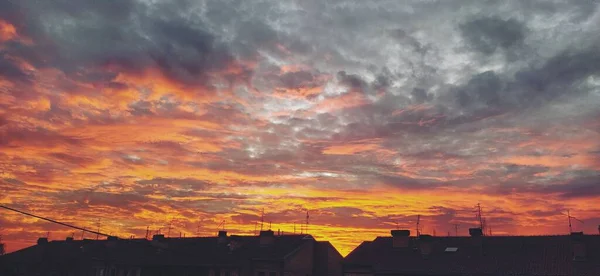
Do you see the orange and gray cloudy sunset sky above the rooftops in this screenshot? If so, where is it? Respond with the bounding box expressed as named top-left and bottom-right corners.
top-left (0, 0), bottom-right (600, 255)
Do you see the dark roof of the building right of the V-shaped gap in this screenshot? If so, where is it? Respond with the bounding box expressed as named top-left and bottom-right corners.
top-left (344, 235), bottom-right (600, 276)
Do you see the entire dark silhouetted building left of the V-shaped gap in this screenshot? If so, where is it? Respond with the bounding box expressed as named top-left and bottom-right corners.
top-left (0, 231), bottom-right (342, 276)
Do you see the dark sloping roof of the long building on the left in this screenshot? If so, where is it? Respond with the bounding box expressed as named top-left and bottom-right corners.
top-left (2, 235), bottom-right (314, 266)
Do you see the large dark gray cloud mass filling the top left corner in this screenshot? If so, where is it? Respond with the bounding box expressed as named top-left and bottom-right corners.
top-left (2, 1), bottom-right (240, 88)
